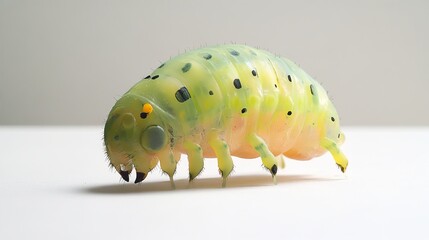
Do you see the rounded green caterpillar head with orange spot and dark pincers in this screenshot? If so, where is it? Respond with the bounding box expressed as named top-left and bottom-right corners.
top-left (104, 95), bottom-right (169, 183)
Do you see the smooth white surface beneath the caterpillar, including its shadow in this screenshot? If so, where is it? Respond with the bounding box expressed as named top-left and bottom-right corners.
top-left (0, 127), bottom-right (429, 240)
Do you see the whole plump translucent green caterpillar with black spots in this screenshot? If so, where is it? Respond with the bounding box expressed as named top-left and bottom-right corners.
top-left (104, 44), bottom-right (348, 187)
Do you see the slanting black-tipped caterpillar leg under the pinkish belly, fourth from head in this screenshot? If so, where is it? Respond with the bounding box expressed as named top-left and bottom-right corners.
top-left (248, 134), bottom-right (277, 182)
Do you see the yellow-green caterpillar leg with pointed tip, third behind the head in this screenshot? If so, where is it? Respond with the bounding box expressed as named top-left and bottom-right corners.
top-left (209, 134), bottom-right (234, 187)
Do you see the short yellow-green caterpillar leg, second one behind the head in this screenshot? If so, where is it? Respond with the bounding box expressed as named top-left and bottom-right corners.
top-left (184, 142), bottom-right (204, 181)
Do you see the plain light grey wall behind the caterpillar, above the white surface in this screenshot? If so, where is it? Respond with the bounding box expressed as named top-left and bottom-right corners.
top-left (0, 0), bottom-right (429, 125)
